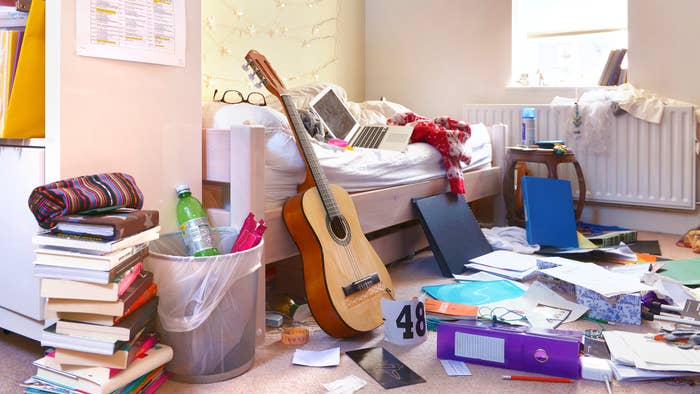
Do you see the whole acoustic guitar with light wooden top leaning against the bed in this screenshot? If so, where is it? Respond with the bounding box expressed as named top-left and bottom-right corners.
top-left (245, 50), bottom-right (394, 338)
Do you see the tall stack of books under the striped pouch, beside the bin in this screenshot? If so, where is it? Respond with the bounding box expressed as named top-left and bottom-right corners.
top-left (25, 210), bottom-right (173, 393)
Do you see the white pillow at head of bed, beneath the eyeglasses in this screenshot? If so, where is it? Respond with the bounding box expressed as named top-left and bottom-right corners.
top-left (202, 102), bottom-right (289, 132)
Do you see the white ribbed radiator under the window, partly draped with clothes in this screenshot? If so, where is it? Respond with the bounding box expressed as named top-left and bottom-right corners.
top-left (464, 104), bottom-right (697, 209)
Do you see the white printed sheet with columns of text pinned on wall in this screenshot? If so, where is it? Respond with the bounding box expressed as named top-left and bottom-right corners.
top-left (76, 0), bottom-right (186, 67)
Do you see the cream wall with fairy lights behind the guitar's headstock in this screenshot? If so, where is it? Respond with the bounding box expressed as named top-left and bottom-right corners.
top-left (202, 0), bottom-right (365, 101)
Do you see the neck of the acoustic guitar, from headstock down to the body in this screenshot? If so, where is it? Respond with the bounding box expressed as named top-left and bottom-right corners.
top-left (280, 94), bottom-right (340, 217)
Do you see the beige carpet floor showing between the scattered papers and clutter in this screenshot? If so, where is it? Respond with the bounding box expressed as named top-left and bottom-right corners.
top-left (0, 229), bottom-right (698, 394)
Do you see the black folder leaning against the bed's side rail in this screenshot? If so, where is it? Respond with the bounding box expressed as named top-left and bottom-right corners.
top-left (412, 193), bottom-right (493, 277)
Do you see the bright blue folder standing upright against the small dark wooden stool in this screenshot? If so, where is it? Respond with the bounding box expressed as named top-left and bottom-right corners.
top-left (521, 176), bottom-right (578, 248)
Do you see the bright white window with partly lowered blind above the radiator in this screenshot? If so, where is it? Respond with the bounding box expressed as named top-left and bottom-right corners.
top-left (512, 0), bottom-right (627, 86)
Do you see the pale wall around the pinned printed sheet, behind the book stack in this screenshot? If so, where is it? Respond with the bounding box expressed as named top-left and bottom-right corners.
top-left (46, 1), bottom-right (202, 232)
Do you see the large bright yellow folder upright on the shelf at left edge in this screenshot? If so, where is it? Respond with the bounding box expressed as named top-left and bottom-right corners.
top-left (2, 0), bottom-right (46, 138)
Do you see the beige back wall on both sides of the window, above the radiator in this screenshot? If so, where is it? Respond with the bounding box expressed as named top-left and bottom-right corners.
top-left (365, 0), bottom-right (700, 117)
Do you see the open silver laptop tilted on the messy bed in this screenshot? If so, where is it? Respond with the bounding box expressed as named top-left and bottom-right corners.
top-left (309, 87), bottom-right (413, 152)
